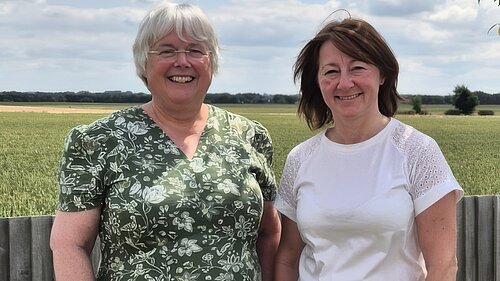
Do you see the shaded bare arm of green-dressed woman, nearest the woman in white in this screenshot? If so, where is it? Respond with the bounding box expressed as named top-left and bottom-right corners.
top-left (257, 201), bottom-right (281, 281)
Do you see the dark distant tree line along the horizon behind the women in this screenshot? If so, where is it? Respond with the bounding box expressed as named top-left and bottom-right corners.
top-left (0, 91), bottom-right (500, 105)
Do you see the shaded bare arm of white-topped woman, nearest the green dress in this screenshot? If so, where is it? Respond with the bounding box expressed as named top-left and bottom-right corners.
top-left (274, 213), bottom-right (305, 281)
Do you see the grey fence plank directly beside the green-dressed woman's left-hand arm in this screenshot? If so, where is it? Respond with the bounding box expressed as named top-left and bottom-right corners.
top-left (31, 216), bottom-right (54, 281)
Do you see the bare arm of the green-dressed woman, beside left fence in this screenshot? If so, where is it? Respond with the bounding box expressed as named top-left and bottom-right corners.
top-left (50, 208), bottom-right (100, 281)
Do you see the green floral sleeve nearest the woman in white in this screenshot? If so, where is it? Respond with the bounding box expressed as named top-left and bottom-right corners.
top-left (252, 121), bottom-right (276, 201)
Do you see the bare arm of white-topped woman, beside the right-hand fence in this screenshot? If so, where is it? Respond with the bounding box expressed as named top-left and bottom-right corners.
top-left (416, 191), bottom-right (457, 281)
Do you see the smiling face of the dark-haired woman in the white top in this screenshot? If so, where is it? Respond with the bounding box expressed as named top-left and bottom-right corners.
top-left (317, 41), bottom-right (383, 122)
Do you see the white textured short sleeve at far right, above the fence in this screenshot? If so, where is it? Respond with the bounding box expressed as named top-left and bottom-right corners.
top-left (407, 136), bottom-right (463, 215)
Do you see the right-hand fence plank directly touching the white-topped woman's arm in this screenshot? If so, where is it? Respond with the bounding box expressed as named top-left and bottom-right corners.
top-left (461, 196), bottom-right (483, 281)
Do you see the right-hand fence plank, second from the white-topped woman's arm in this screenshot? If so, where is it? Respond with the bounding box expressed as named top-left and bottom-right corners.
top-left (476, 196), bottom-right (494, 280)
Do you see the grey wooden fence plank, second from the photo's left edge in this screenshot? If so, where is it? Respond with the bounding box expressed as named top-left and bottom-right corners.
top-left (9, 217), bottom-right (32, 281)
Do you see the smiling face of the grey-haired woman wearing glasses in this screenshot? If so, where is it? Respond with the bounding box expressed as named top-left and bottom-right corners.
top-left (145, 32), bottom-right (212, 105)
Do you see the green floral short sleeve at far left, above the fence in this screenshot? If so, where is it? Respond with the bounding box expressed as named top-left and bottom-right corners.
top-left (58, 126), bottom-right (104, 212)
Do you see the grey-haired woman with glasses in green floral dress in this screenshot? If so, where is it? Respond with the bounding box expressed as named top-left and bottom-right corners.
top-left (51, 4), bottom-right (280, 281)
